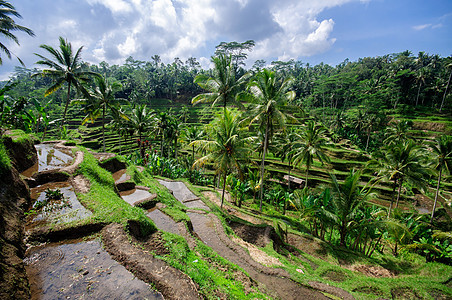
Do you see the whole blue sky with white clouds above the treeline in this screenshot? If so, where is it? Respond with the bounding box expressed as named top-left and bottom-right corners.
top-left (0, 0), bottom-right (452, 80)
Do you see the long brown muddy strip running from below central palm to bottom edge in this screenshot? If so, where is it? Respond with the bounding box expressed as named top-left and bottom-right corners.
top-left (159, 180), bottom-right (328, 299)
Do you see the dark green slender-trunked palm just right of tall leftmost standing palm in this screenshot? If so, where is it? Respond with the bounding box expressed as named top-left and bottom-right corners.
top-left (77, 76), bottom-right (127, 152)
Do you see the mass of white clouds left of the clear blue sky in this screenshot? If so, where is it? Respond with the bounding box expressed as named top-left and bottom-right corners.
top-left (0, 0), bottom-right (367, 77)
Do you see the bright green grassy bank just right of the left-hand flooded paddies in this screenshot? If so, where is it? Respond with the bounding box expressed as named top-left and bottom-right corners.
top-left (77, 148), bottom-right (157, 235)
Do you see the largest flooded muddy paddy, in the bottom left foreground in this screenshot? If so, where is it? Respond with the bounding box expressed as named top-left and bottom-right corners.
top-left (25, 239), bottom-right (163, 299)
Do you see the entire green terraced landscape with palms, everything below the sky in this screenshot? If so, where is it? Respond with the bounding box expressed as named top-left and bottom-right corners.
top-left (0, 1), bottom-right (452, 299)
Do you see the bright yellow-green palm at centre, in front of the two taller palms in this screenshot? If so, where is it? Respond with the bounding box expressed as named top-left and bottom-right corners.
top-left (190, 108), bottom-right (252, 208)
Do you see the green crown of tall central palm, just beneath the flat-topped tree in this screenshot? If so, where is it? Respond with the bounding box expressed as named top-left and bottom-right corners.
top-left (191, 54), bottom-right (250, 108)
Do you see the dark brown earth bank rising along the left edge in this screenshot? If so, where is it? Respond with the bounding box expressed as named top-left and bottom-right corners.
top-left (0, 132), bottom-right (37, 299)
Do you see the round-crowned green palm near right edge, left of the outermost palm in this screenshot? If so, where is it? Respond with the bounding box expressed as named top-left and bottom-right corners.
top-left (370, 140), bottom-right (430, 217)
